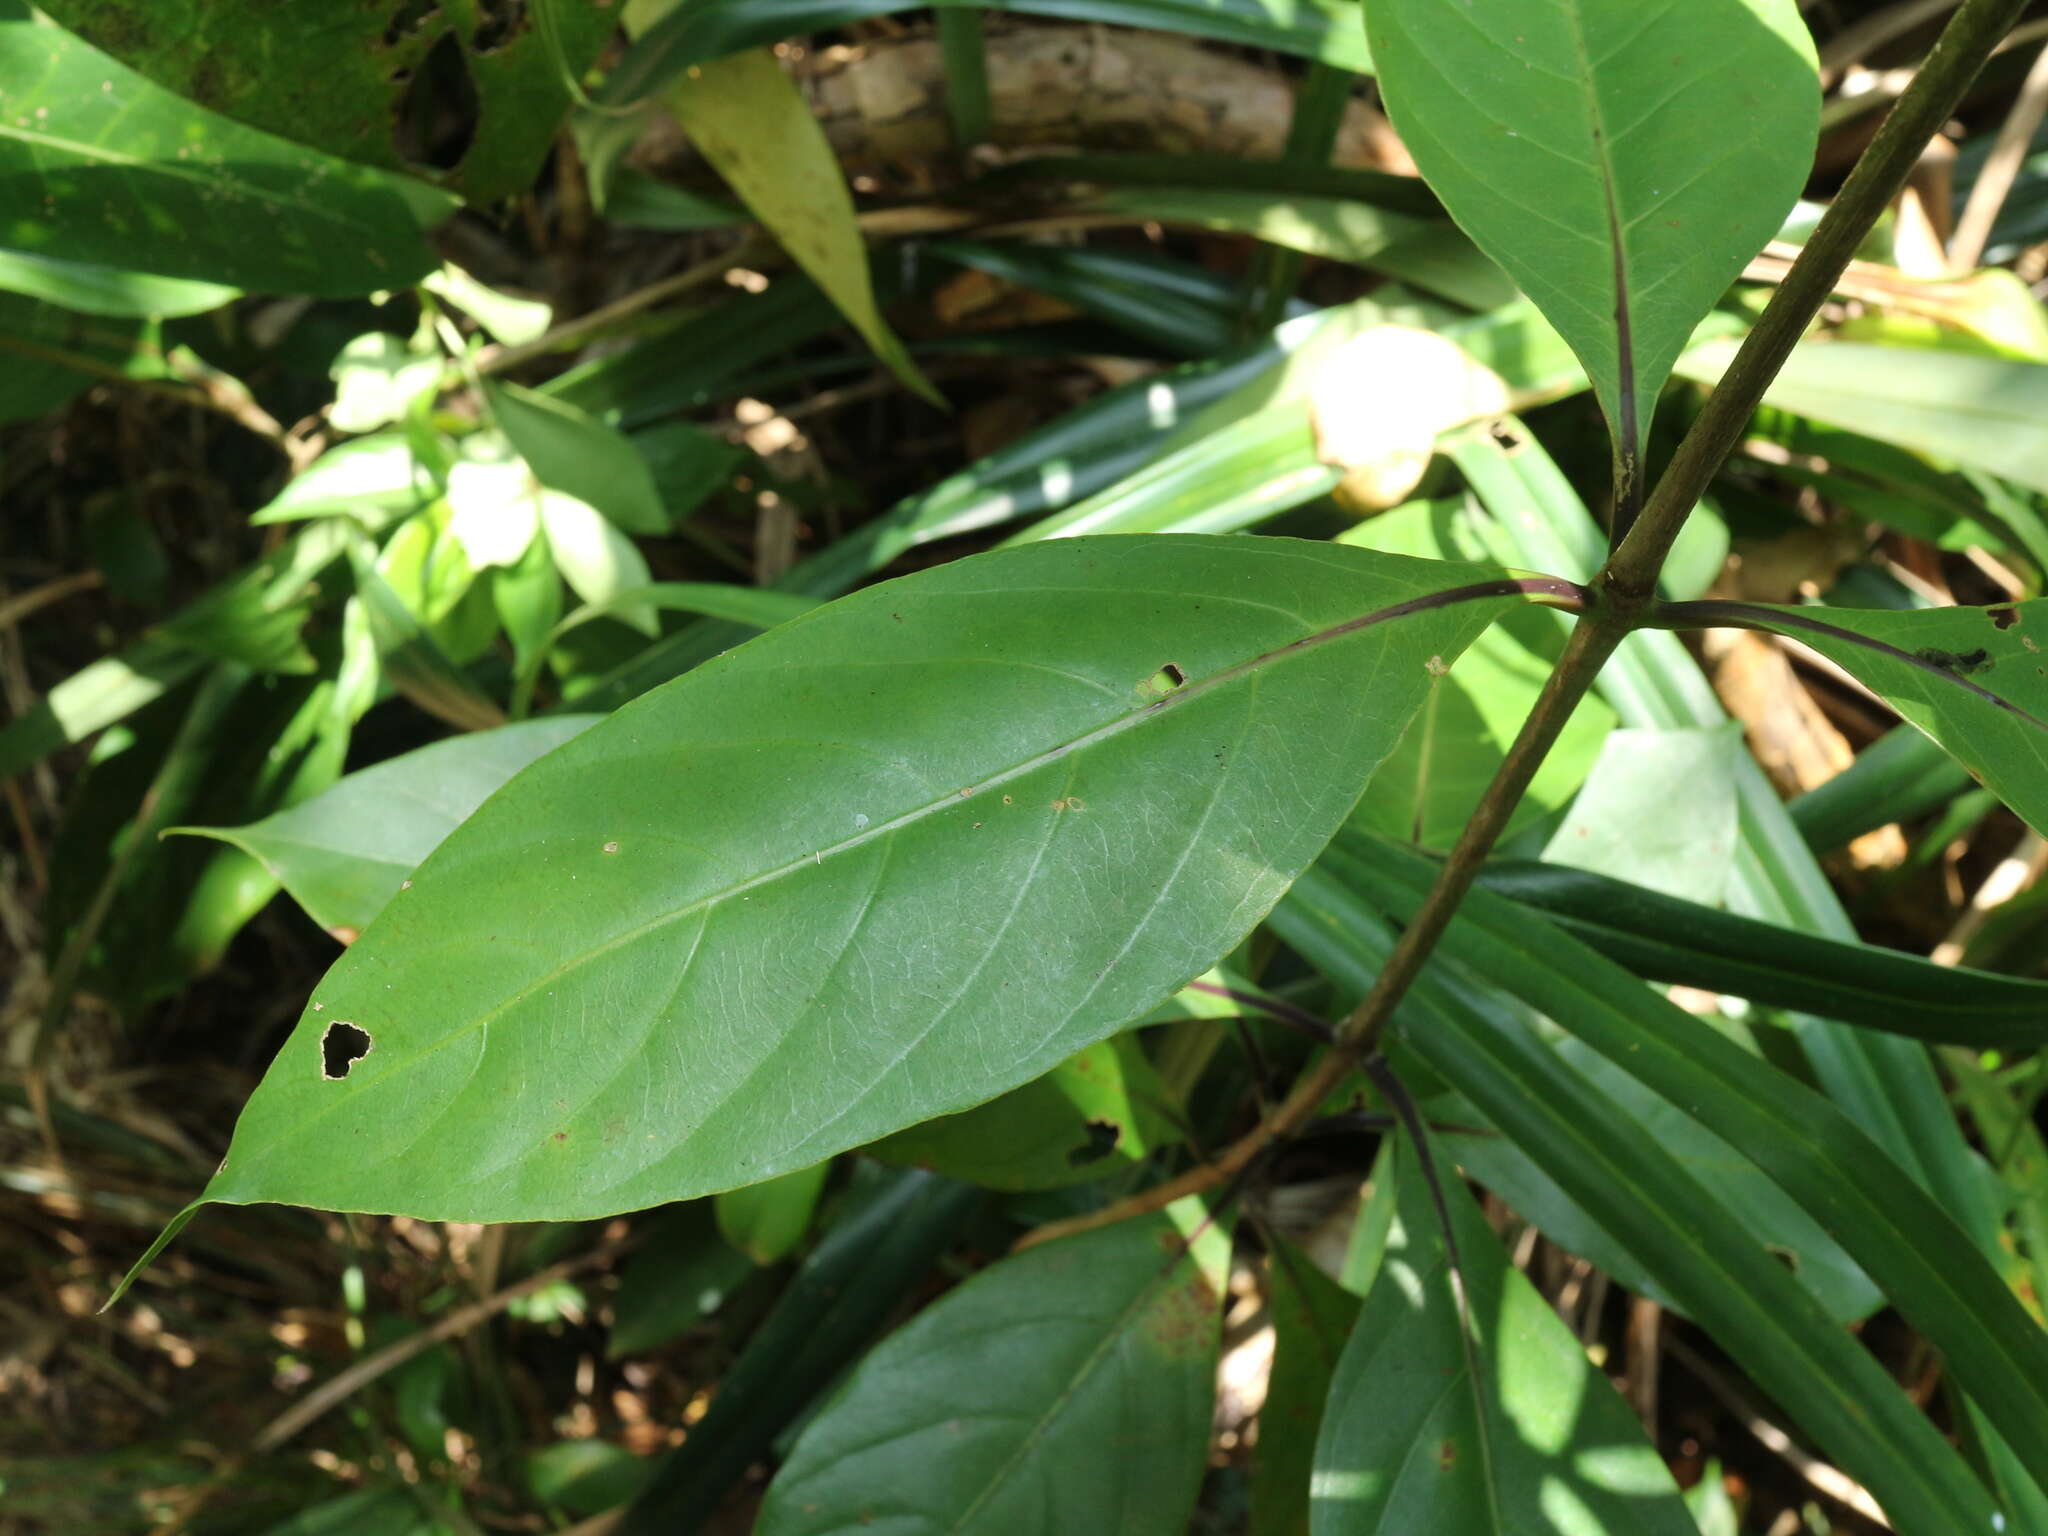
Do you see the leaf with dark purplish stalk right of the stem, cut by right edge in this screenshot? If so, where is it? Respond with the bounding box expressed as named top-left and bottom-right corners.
top-left (1657, 598), bottom-right (2048, 843)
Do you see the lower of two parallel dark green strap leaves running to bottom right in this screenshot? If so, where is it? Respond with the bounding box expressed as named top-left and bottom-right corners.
top-left (1276, 881), bottom-right (1997, 1536)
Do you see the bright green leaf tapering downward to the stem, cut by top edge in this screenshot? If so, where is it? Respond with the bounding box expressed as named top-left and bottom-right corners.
top-left (1366, 0), bottom-right (1821, 455)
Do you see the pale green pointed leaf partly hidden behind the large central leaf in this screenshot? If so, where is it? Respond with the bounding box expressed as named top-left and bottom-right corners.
top-left (172, 715), bottom-right (598, 938)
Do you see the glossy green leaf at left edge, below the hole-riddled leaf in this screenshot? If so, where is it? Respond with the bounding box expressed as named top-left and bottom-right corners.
top-left (0, 4), bottom-right (444, 294)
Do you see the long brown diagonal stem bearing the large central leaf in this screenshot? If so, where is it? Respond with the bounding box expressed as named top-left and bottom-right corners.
top-left (1018, 0), bottom-right (2028, 1247)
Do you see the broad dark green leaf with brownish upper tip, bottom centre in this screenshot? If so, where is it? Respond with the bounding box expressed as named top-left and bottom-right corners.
top-left (756, 1202), bottom-right (1229, 1536)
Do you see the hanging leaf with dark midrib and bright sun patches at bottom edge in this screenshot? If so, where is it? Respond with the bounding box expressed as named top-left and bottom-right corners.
top-left (1309, 1143), bottom-right (1698, 1536)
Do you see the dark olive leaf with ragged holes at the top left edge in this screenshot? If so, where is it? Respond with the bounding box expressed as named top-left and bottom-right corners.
top-left (43, 0), bottom-right (618, 204)
